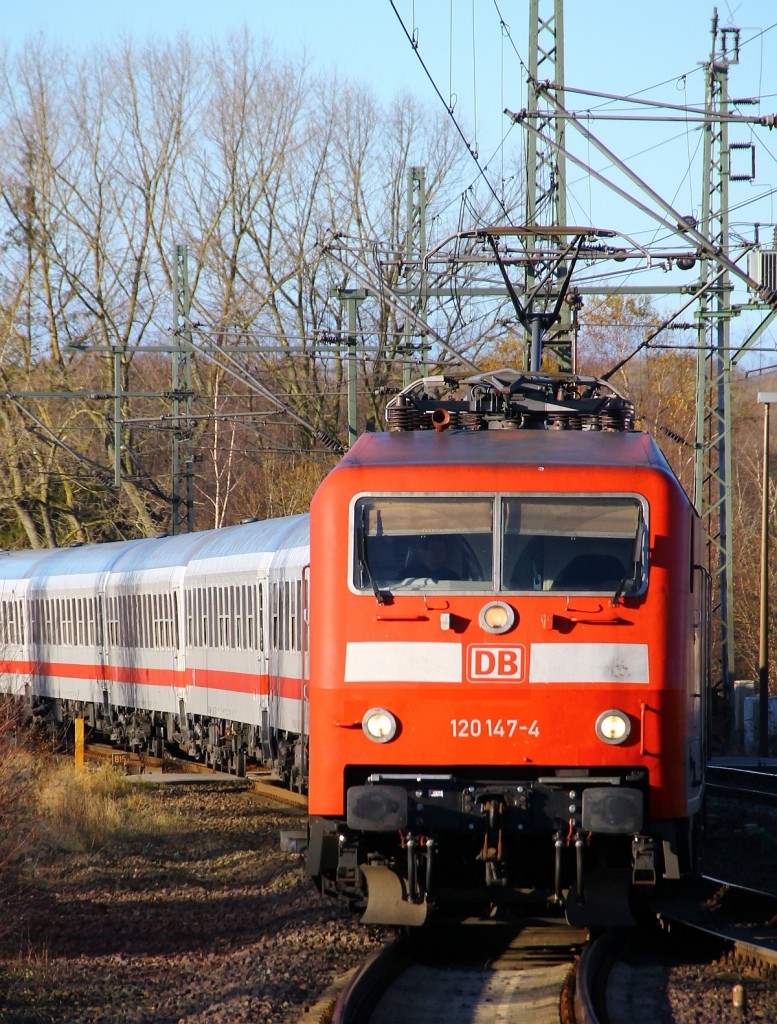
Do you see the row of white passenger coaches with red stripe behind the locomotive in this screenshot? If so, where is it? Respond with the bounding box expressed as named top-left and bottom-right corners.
top-left (0, 515), bottom-right (308, 788)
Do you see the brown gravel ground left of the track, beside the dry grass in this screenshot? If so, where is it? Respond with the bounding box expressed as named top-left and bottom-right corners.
top-left (0, 785), bottom-right (385, 1024)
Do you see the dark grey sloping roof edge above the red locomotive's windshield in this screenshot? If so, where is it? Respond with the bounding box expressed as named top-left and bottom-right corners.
top-left (340, 430), bottom-right (671, 472)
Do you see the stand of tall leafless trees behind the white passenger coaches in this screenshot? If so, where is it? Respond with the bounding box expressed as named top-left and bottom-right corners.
top-left (0, 33), bottom-right (522, 545)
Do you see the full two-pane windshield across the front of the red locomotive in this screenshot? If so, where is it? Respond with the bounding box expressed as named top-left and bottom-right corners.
top-left (353, 495), bottom-right (647, 595)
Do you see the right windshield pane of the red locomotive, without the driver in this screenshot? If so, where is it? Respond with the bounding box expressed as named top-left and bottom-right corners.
top-left (501, 495), bottom-right (646, 596)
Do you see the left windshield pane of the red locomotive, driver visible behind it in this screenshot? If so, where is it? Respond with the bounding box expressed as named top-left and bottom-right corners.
top-left (353, 495), bottom-right (493, 591)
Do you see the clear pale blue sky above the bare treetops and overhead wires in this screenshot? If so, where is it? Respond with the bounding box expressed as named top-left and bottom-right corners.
top-left (0, 0), bottom-right (777, 352)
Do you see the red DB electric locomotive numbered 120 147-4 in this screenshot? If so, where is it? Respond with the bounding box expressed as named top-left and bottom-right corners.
top-left (307, 372), bottom-right (707, 925)
